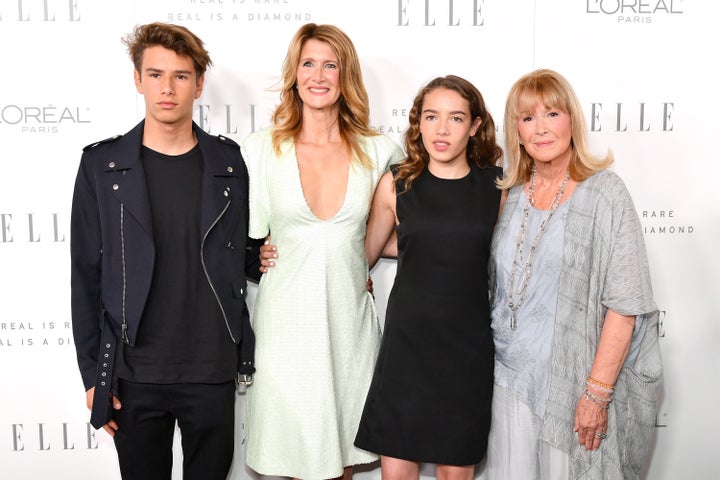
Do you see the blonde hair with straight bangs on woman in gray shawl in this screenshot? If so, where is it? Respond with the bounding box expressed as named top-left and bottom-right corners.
top-left (498, 69), bottom-right (613, 188)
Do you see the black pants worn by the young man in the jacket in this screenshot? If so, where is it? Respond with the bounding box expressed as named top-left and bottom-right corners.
top-left (114, 380), bottom-right (235, 480)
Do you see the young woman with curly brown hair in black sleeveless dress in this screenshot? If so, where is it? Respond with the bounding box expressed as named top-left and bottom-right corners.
top-left (355, 76), bottom-right (502, 480)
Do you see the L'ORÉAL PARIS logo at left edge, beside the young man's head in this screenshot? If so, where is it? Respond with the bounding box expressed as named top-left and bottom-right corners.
top-left (0, 105), bottom-right (91, 134)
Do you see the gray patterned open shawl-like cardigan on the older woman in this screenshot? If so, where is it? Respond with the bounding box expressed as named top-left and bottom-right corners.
top-left (489, 170), bottom-right (662, 480)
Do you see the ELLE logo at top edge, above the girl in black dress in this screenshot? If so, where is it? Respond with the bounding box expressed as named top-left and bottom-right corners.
top-left (397, 0), bottom-right (485, 27)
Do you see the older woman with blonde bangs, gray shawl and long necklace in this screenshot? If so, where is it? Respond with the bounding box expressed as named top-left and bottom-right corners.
top-left (487, 70), bottom-right (661, 479)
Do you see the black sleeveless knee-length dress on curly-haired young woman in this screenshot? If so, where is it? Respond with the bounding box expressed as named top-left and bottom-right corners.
top-left (355, 164), bottom-right (502, 466)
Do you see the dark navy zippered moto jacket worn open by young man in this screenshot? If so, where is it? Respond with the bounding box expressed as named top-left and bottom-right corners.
top-left (70, 121), bottom-right (260, 428)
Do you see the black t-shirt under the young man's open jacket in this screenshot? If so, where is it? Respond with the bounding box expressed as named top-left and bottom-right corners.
top-left (115, 142), bottom-right (237, 384)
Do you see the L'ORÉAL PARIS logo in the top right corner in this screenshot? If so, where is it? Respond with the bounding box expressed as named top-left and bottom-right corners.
top-left (585, 0), bottom-right (685, 24)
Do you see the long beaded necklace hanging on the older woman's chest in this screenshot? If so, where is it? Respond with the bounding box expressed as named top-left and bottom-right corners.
top-left (508, 165), bottom-right (570, 330)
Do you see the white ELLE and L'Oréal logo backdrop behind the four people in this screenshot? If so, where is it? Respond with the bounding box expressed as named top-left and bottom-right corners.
top-left (0, 0), bottom-right (720, 480)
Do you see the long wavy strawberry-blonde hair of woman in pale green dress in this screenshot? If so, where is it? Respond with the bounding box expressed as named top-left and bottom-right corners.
top-left (272, 23), bottom-right (377, 167)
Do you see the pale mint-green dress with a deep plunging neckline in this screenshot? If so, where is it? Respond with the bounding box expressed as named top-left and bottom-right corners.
top-left (242, 129), bottom-right (404, 480)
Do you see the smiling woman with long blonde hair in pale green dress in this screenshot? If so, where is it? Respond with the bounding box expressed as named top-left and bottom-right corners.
top-left (242, 24), bottom-right (403, 479)
